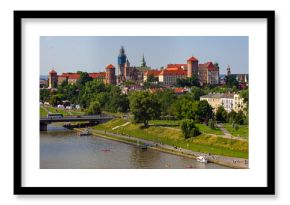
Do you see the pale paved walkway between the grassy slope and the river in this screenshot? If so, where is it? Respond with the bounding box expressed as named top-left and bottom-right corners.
top-left (85, 129), bottom-right (248, 169)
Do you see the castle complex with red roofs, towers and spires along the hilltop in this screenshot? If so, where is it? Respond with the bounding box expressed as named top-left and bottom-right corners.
top-left (47, 46), bottom-right (248, 88)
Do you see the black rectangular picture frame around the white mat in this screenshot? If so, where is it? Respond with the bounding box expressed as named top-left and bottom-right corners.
top-left (14, 11), bottom-right (275, 195)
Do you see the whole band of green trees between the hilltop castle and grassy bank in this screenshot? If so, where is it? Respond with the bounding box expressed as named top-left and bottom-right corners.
top-left (40, 72), bottom-right (248, 137)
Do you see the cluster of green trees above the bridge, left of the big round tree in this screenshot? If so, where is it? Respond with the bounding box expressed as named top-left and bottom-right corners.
top-left (40, 72), bottom-right (129, 114)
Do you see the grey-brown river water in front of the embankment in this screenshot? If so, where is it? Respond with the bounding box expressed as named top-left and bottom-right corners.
top-left (40, 125), bottom-right (228, 169)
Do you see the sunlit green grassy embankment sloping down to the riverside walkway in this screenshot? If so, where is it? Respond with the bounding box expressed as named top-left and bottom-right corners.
top-left (93, 118), bottom-right (248, 158)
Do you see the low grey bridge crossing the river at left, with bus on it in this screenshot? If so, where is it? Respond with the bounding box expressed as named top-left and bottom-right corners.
top-left (40, 115), bottom-right (113, 131)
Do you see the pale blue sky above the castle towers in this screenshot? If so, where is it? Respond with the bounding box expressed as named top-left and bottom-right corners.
top-left (40, 36), bottom-right (249, 75)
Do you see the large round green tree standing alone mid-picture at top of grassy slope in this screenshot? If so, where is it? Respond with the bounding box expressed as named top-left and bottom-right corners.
top-left (129, 92), bottom-right (160, 127)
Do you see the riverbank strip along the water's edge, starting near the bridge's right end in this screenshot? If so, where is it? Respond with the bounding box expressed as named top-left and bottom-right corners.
top-left (74, 128), bottom-right (248, 169)
